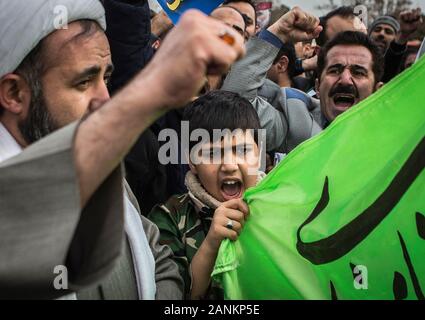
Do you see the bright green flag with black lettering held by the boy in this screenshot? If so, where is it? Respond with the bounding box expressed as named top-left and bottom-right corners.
top-left (213, 58), bottom-right (425, 299)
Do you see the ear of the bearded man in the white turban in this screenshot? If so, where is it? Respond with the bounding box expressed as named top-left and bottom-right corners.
top-left (0, 73), bottom-right (31, 115)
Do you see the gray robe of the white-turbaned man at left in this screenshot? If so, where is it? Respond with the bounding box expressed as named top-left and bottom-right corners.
top-left (0, 123), bottom-right (183, 299)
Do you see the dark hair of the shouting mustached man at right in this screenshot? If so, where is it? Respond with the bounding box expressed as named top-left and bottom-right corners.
top-left (317, 31), bottom-right (384, 84)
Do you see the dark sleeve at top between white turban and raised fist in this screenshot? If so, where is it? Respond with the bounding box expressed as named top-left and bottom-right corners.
top-left (104, 0), bottom-right (153, 93)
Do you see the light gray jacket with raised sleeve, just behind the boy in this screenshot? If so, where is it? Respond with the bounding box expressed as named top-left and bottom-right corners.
top-left (221, 37), bottom-right (322, 153)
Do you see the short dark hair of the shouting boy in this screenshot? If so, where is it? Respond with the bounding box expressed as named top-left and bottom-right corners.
top-left (183, 90), bottom-right (261, 150)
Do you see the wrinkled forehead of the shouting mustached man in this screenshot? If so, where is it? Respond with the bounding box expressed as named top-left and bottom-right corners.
top-left (326, 45), bottom-right (373, 69)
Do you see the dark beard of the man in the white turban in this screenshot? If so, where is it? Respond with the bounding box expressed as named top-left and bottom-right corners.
top-left (18, 85), bottom-right (59, 144)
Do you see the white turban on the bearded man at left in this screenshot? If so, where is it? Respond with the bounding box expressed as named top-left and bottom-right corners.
top-left (0, 0), bottom-right (106, 78)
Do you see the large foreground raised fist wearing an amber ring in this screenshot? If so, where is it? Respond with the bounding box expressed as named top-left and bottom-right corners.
top-left (135, 10), bottom-right (245, 109)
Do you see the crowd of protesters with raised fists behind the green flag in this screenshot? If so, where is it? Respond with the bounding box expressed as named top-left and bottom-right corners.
top-left (0, 0), bottom-right (422, 299)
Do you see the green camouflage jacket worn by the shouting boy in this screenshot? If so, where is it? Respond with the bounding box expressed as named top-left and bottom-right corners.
top-left (149, 193), bottom-right (223, 300)
